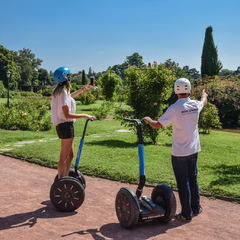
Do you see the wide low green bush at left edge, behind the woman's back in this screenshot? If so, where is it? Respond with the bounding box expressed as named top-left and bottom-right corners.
top-left (0, 98), bottom-right (52, 131)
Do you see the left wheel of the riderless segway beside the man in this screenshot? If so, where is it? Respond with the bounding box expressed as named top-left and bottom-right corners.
top-left (115, 188), bottom-right (139, 228)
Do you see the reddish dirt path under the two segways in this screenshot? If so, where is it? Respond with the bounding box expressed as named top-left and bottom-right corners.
top-left (0, 155), bottom-right (240, 240)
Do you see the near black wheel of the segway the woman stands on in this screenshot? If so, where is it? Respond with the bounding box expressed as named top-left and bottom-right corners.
top-left (50, 177), bottom-right (85, 212)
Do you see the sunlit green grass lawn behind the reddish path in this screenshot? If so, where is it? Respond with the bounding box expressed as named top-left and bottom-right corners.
top-left (0, 99), bottom-right (240, 198)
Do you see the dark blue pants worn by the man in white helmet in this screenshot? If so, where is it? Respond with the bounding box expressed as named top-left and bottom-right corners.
top-left (172, 153), bottom-right (200, 218)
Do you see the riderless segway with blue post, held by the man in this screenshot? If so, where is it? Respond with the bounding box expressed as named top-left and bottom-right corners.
top-left (115, 118), bottom-right (176, 228)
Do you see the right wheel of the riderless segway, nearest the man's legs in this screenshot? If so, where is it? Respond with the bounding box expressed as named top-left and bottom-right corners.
top-left (151, 184), bottom-right (177, 223)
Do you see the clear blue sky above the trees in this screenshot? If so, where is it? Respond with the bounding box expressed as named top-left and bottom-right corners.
top-left (0, 0), bottom-right (240, 73)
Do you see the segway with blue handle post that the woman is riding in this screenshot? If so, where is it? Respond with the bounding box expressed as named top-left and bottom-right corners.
top-left (50, 118), bottom-right (93, 212)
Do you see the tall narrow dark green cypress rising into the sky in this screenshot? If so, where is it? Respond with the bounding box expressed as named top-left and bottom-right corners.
top-left (201, 26), bottom-right (222, 76)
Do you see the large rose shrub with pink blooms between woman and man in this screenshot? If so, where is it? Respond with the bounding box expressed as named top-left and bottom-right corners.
top-left (116, 62), bottom-right (176, 143)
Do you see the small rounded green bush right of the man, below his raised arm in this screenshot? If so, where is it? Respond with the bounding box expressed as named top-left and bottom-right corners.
top-left (198, 102), bottom-right (222, 134)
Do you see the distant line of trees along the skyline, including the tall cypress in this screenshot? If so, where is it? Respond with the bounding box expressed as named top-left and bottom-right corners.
top-left (0, 26), bottom-right (240, 90)
